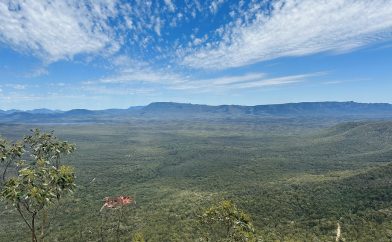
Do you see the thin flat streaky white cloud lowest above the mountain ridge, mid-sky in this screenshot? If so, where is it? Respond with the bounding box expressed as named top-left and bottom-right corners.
top-left (87, 62), bottom-right (327, 93)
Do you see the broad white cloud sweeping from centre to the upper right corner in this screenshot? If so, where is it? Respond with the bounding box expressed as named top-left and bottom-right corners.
top-left (181, 0), bottom-right (392, 69)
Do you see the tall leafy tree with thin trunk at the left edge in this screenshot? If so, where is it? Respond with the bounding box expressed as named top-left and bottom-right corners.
top-left (0, 129), bottom-right (76, 242)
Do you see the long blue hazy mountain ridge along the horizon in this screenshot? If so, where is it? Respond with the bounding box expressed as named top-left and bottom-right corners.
top-left (0, 102), bottom-right (392, 123)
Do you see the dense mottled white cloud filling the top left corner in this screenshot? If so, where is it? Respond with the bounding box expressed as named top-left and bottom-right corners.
top-left (0, 0), bottom-right (118, 62)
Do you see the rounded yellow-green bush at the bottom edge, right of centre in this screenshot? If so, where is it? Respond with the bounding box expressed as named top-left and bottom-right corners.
top-left (200, 200), bottom-right (256, 241)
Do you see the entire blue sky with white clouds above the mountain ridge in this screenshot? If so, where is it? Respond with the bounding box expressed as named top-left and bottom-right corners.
top-left (0, 0), bottom-right (392, 110)
